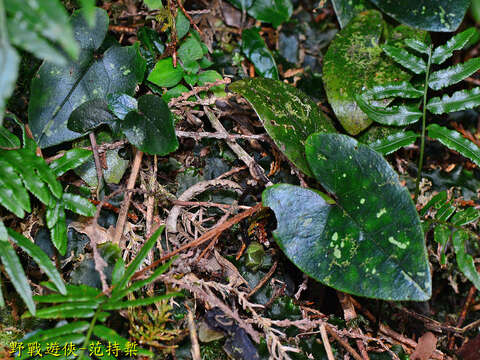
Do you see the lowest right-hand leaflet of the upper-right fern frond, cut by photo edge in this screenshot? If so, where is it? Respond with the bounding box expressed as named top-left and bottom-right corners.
top-left (427, 124), bottom-right (480, 166)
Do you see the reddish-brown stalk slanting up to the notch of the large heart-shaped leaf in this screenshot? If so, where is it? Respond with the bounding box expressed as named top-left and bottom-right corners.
top-left (132, 203), bottom-right (262, 280)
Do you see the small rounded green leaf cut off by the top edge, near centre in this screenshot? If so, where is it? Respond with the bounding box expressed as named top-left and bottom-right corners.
top-left (248, 0), bottom-right (293, 27)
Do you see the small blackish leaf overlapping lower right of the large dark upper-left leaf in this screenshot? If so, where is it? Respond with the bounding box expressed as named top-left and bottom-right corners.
top-left (67, 99), bottom-right (117, 134)
